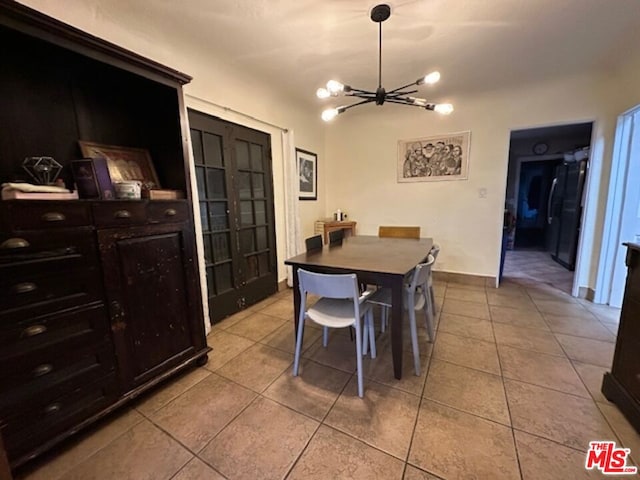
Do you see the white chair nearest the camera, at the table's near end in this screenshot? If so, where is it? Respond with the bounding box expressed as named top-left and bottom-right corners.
top-left (293, 269), bottom-right (376, 397)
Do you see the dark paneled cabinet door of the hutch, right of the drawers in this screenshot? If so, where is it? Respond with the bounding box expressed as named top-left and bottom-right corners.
top-left (98, 224), bottom-right (199, 390)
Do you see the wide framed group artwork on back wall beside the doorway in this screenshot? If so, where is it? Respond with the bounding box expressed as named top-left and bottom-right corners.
top-left (398, 132), bottom-right (471, 183)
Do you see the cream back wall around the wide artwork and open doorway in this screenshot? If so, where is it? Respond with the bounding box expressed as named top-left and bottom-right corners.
top-left (326, 76), bottom-right (615, 283)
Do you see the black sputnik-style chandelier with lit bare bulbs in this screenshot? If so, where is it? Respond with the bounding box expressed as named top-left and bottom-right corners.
top-left (316, 3), bottom-right (453, 122)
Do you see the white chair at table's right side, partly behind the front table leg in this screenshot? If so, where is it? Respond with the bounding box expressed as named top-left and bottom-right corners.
top-left (363, 254), bottom-right (435, 376)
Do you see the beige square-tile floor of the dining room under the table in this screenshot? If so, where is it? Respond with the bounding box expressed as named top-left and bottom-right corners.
top-left (18, 278), bottom-right (640, 480)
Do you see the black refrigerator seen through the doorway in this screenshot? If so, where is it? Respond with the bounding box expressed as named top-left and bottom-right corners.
top-left (546, 158), bottom-right (588, 271)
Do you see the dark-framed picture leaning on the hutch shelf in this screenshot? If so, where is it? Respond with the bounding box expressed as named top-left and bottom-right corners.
top-left (78, 140), bottom-right (160, 190)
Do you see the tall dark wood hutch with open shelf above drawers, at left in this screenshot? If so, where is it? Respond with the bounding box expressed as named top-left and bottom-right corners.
top-left (0, 0), bottom-right (209, 468)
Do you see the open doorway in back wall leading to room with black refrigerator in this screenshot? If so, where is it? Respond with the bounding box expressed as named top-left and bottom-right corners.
top-left (501, 122), bottom-right (593, 295)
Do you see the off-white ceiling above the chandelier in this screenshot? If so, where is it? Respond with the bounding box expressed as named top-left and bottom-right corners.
top-left (32, 0), bottom-right (640, 105)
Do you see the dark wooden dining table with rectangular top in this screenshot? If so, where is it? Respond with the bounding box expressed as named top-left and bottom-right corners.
top-left (284, 236), bottom-right (433, 379)
